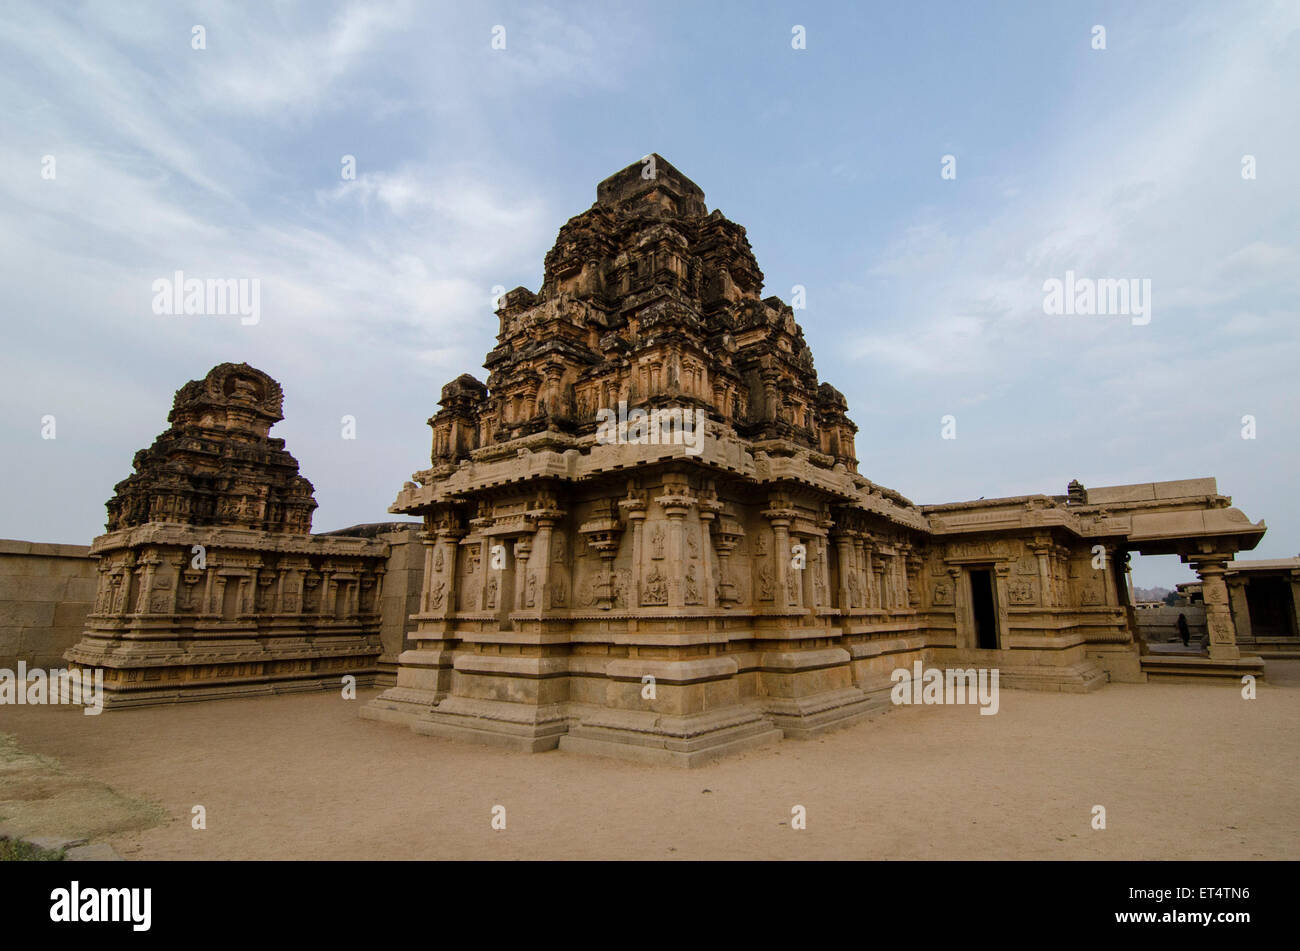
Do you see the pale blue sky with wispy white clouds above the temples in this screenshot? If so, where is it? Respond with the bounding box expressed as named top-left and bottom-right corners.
top-left (0, 0), bottom-right (1300, 587)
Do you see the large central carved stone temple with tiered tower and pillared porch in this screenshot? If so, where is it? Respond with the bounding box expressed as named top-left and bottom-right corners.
top-left (363, 156), bottom-right (1265, 765)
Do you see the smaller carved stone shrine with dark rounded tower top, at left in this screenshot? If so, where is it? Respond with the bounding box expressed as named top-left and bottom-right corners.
top-left (65, 364), bottom-right (389, 707)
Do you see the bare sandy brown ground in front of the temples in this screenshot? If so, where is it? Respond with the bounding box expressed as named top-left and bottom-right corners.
top-left (0, 661), bottom-right (1300, 859)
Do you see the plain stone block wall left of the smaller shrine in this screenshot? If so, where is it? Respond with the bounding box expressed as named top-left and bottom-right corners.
top-left (0, 539), bottom-right (99, 670)
